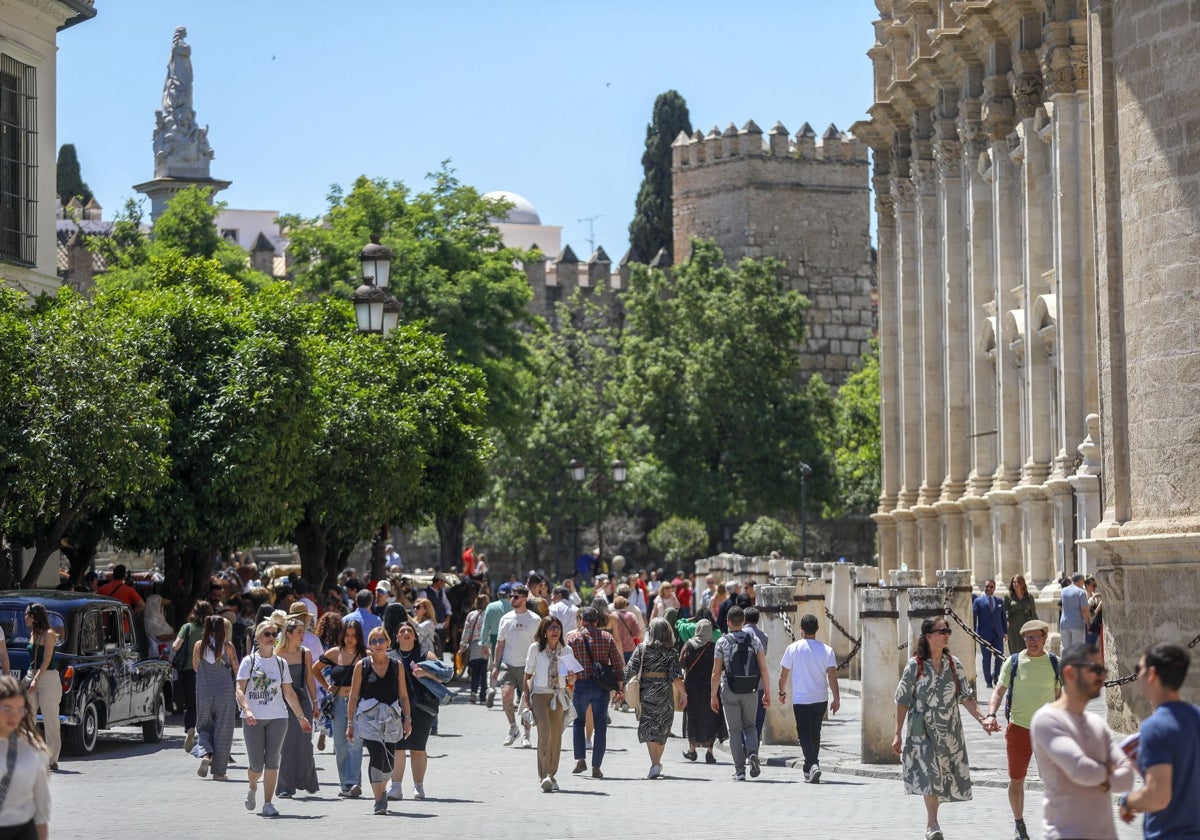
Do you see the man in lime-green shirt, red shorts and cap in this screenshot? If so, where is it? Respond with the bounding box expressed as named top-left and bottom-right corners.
top-left (984, 619), bottom-right (1062, 840)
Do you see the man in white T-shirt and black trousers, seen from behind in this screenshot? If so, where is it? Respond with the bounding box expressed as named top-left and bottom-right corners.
top-left (779, 613), bottom-right (841, 785)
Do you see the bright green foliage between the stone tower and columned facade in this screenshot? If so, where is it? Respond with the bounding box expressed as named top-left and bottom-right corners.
top-left (826, 342), bottom-right (882, 516)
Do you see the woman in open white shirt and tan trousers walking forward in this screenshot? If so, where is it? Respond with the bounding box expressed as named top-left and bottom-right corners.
top-left (524, 616), bottom-right (583, 793)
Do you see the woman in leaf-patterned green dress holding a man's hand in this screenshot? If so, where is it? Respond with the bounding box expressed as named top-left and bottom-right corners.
top-left (892, 616), bottom-right (991, 840)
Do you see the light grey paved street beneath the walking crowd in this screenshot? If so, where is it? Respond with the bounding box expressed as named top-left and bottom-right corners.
top-left (50, 686), bottom-right (1141, 840)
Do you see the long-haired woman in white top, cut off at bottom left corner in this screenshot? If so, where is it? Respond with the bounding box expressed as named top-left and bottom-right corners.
top-left (0, 676), bottom-right (50, 840)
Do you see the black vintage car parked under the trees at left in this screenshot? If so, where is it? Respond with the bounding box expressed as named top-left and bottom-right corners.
top-left (0, 589), bottom-right (170, 755)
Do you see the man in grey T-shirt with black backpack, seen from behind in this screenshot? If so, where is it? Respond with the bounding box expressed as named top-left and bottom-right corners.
top-left (709, 607), bottom-right (770, 781)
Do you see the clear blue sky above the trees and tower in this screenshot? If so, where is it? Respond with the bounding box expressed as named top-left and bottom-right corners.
top-left (58, 0), bottom-right (877, 262)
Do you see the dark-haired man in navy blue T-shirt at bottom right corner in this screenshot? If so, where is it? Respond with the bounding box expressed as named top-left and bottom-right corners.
top-left (1121, 642), bottom-right (1200, 840)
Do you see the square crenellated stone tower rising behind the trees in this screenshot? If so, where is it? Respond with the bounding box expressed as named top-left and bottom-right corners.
top-left (672, 121), bottom-right (875, 385)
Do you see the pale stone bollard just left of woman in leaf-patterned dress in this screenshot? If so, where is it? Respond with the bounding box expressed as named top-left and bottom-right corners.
top-left (858, 589), bottom-right (902, 764)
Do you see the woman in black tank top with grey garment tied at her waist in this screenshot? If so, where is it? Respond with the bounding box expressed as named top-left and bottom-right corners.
top-left (346, 626), bottom-right (413, 815)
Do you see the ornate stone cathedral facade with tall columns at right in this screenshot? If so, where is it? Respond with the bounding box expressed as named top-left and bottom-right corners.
top-left (853, 0), bottom-right (1200, 724)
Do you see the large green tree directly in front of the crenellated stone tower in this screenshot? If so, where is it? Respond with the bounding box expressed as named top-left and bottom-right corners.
top-left (623, 240), bottom-right (823, 546)
